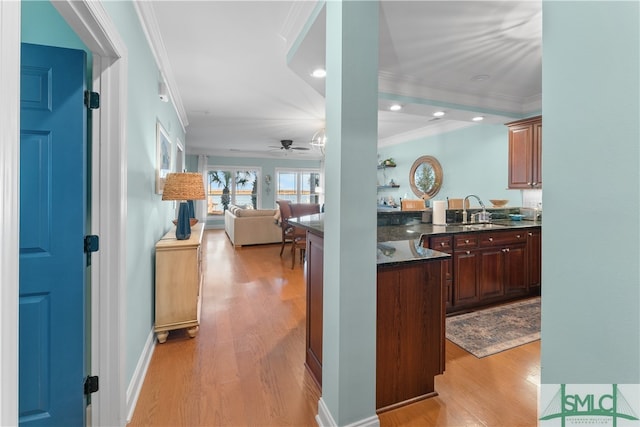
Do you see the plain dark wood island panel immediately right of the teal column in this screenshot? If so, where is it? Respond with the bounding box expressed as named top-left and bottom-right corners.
top-left (376, 260), bottom-right (445, 413)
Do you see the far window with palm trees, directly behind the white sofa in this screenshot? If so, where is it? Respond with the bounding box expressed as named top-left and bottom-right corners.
top-left (207, 167), bottom-right (261, 215)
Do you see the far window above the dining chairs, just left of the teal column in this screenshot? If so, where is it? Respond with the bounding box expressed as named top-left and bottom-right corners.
top-left (276, 169), bottom-right (320, 203)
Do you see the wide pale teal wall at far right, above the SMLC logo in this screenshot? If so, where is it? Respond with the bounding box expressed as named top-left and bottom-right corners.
top-left (541, 1), bottom-right (640, 384)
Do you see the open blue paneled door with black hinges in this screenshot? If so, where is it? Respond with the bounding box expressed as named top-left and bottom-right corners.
top-left (19, 44), bottom-right (87, 426)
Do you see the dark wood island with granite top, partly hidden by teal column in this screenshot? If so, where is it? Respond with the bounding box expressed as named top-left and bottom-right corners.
top-left (292, 214), bottom-right (450, 412)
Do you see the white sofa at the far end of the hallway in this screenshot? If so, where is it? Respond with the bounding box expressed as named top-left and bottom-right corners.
top-left (224, 205), bottom-right (282, 248)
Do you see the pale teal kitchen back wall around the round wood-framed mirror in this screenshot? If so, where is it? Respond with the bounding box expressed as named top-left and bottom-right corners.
top-left (378, 125), bottom-right (522, 206)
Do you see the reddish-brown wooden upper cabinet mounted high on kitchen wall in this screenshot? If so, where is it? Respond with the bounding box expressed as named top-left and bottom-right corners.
top-left (507, 116), bottom-right (542, 189)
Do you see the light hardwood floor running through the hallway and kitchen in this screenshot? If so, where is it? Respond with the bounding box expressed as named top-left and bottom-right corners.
top-left (129, 230), bottom-right (540, 427)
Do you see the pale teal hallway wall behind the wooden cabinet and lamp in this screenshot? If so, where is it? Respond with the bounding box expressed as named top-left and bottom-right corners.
top-left (103, 1), bottom-right (185, 381)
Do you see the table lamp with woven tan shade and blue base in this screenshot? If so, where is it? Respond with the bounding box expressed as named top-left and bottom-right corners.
top-left (162, 172), bottom-right (205, 240)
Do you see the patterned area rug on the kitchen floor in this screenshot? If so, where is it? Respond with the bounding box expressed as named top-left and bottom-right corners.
top-left (446, 297), bottom-right (540, 358)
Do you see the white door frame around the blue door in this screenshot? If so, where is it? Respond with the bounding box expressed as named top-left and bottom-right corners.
top-left (0, 0), bottom-right (127, 426)
